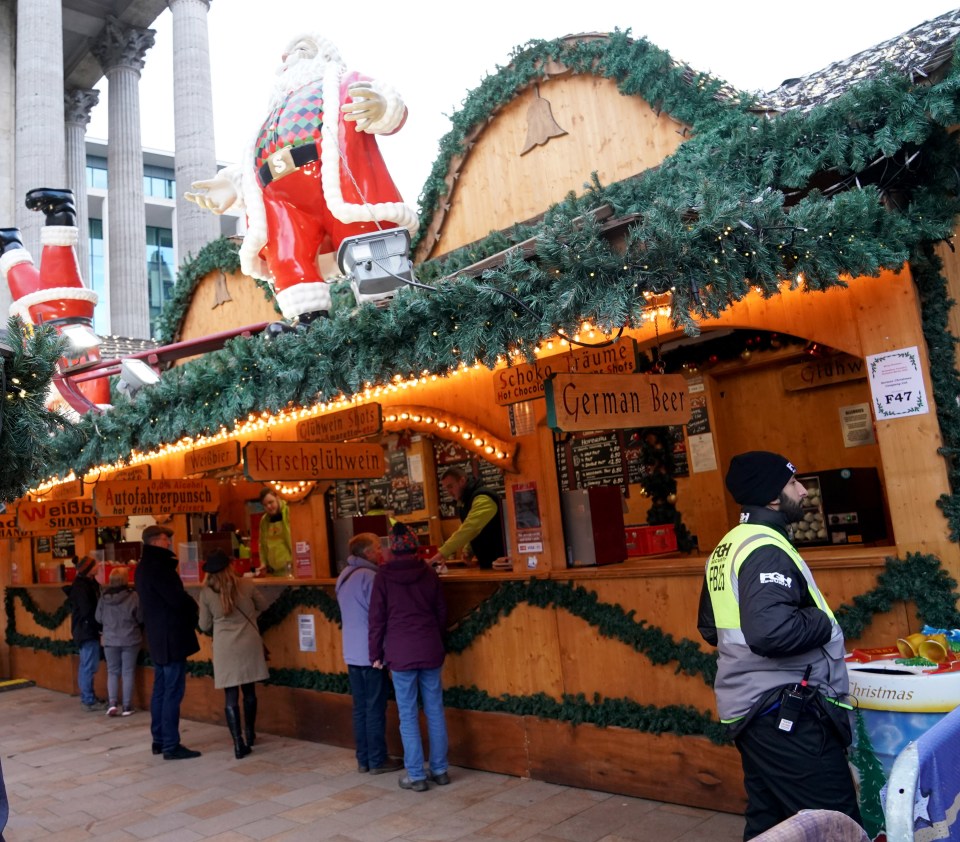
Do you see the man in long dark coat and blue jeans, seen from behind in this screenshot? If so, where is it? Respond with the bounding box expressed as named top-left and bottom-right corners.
top-left (135, 526), bottom-right (200, 760)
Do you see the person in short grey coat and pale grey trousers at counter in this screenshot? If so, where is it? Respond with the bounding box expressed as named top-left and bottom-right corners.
top-left (97, 567), bottom-right (143, 716)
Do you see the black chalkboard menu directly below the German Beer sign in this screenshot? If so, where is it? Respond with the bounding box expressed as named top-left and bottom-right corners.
top-left (554, 426), bottom-right (689, 491)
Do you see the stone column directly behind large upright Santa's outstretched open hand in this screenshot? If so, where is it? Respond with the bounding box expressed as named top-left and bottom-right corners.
top-left (167, 0), bottom-right (220, 263)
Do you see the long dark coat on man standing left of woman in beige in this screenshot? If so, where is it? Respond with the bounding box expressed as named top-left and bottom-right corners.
top-left (134, 544), bottom-right (200, 664)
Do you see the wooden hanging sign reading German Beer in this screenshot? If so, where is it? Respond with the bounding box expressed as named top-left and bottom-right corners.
top-left (545, 374), bottom-right (690, 432)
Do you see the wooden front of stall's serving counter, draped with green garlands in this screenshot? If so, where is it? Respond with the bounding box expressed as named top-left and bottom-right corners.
top-left (6, 547), bottom-right (911, 811)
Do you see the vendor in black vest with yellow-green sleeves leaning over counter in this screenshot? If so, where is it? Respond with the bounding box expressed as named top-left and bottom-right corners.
top-left (430, 468), bottom-right (504, 570)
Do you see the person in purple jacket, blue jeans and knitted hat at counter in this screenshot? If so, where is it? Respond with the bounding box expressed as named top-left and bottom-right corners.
top-left (368, 523), bottom-right (450, 792)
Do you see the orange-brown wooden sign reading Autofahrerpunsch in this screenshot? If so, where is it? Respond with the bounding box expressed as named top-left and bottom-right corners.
top-left (93, 479), bottom-right (220, 517)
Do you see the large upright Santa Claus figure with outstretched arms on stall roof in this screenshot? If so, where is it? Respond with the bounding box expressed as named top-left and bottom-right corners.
top-left (186, 34), bottom-right (418, 321)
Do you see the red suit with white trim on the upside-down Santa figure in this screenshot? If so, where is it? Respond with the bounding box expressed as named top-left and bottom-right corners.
top-left (0, 225), bottom-right (110, 404)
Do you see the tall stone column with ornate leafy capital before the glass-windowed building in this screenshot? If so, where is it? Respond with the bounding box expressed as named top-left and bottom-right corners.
top-left (92, 15), bottom-right (154, 339)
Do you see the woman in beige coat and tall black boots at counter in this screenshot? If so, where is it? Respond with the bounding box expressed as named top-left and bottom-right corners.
top-left (197, 550), bottom-right (270, 760)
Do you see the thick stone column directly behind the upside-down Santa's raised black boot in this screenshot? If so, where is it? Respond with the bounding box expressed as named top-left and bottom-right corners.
top-left (13, 0), bottom-right (67, 260)
